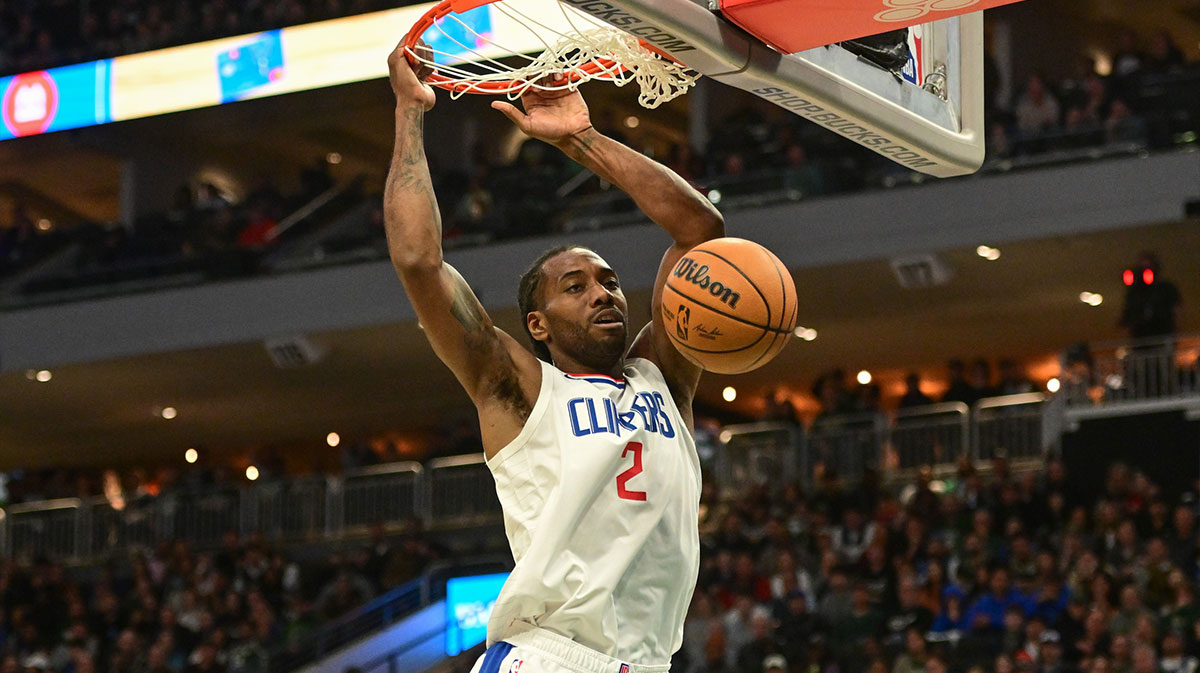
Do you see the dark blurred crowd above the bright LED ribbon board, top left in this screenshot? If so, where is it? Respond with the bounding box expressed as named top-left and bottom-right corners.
top-left (0, 0), bottom-right (396, 77)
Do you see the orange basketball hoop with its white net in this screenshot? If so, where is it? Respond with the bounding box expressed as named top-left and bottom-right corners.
top-left (403, 0), bottom-right (700, 108)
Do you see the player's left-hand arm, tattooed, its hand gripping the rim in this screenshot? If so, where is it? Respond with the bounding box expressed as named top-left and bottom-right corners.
top-left (384, 47), bottom-right (541, 456)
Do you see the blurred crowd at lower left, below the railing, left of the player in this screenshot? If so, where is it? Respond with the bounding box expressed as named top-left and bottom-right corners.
top-left (0, 523), bottom-right (442, 673)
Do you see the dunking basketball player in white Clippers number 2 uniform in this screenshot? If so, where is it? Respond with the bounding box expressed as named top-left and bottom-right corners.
top-left (384, 41), bottom-right (724, 673)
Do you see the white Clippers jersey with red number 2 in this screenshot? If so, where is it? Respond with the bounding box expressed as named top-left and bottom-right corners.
top-left (487, 359), bottom-right (701, 665)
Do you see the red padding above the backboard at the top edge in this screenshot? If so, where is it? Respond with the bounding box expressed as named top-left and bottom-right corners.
top-left (720, 0), bottom-right (1020, 54)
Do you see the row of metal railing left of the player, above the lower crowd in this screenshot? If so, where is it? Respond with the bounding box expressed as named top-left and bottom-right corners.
top-left (0, 456), bottom-right (463, 563)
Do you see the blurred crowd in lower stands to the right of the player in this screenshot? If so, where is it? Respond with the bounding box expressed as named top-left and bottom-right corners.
top-left (672, 458), bottom-right (1200, 673)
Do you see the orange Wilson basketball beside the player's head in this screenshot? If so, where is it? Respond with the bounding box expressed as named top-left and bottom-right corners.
top-left (662, 238), bottom-right (797, 374)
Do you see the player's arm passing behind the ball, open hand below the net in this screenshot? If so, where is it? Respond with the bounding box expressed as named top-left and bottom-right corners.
top-left (492, 90), bottom-right (725, 421)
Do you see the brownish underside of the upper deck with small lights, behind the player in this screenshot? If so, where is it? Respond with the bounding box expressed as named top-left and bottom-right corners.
top-left (0, 221), bottom-right (1200, 470)
